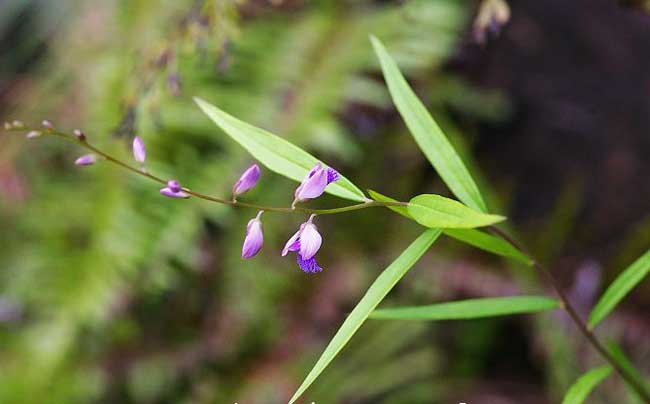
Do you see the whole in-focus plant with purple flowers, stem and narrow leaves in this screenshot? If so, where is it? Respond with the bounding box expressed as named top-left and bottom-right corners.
top-left (5, 37), bottom-right (650, 403)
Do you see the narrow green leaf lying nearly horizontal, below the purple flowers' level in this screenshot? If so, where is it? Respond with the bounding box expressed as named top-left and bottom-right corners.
top-left (370, 296), bottom-right (560, 321)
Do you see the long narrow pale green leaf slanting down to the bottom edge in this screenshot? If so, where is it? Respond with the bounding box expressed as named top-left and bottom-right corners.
top-left (289, 229), bottom-right (440, 404)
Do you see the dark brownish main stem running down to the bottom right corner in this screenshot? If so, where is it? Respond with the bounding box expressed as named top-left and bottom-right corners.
top-left (489, 226), bottom-right (650, 404)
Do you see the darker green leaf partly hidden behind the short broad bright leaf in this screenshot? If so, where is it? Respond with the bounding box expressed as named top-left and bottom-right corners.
top-left (368, 189), bottom-right (532, 266)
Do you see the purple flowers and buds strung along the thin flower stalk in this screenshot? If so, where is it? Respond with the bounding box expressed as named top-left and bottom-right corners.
top-left (69, 131), bottom-right (339, 273)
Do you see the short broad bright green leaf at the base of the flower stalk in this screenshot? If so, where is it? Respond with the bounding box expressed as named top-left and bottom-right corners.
top-left (408, 194), bottom-right (505, 228)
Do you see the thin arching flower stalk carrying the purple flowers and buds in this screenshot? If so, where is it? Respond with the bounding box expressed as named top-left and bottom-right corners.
top-left (9, 126), bottom-right (408, 215)
